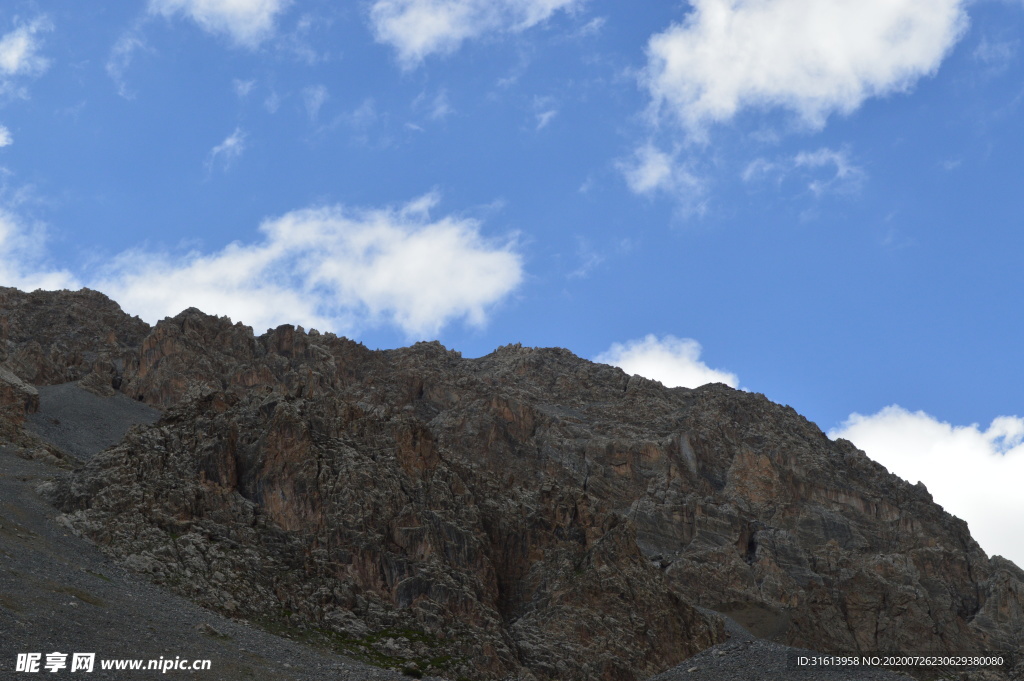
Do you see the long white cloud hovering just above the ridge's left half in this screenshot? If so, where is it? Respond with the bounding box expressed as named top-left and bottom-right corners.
top-left (90, 195), bottom-right (522, 338)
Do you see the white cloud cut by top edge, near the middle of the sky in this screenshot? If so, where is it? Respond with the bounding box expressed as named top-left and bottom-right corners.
top-left (370, 0), bottom-right (583, 68)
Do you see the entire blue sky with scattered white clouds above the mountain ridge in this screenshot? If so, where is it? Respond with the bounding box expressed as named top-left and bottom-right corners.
top-left (0, 0), bottom-right (1024, 563)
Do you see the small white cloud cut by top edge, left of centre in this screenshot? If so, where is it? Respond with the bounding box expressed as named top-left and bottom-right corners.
top-left (150, 0), bottom-right (290, 48)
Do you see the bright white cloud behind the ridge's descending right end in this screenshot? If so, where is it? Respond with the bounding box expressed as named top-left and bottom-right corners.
top-left (828, 405), bottom-right (1024, 565)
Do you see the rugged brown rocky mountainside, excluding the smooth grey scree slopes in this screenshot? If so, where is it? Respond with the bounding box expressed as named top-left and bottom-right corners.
top-left (0, 289), bottom-right (1024, 680)
